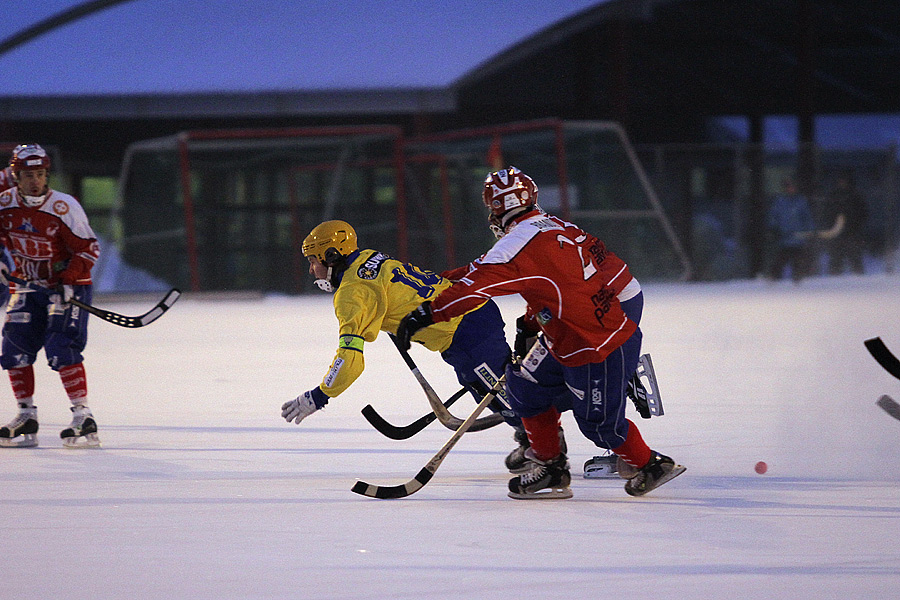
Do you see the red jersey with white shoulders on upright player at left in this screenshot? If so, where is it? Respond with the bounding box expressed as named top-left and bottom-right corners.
top-left (0, 188), bottom-right (100, 287)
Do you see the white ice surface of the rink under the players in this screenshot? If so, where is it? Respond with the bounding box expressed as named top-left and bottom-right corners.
top-left (0, 275), bottom-right (900, 600)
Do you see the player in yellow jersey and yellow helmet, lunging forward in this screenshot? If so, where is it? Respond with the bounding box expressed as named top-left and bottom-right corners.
top-left (281, 221), bottom-right (544, 469)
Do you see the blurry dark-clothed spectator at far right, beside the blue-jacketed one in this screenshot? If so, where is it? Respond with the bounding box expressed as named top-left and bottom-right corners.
top-left (822, 173), bottom-right (867, 275)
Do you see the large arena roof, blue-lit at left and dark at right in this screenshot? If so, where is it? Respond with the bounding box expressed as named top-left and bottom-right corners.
top-left (0, 0), bottom-right (900, 144)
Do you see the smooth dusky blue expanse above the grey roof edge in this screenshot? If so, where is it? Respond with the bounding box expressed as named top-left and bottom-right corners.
top-left (0, 0), bottom-right (602, 96)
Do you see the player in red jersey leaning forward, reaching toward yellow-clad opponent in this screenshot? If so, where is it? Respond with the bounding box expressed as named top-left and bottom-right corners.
top-left (398, 167), bottom-right (685, 499)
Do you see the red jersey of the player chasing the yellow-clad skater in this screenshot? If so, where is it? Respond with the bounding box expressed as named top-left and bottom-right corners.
top-left (431, 212), bottom-right (639, 367)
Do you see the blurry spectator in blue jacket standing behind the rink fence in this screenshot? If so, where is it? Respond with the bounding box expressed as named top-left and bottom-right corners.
top-left (767, 178), bottom-right (816, 281)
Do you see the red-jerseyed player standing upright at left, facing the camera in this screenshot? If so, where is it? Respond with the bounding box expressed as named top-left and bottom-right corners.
top-left (0, 144), bottom-right (100, 447)
